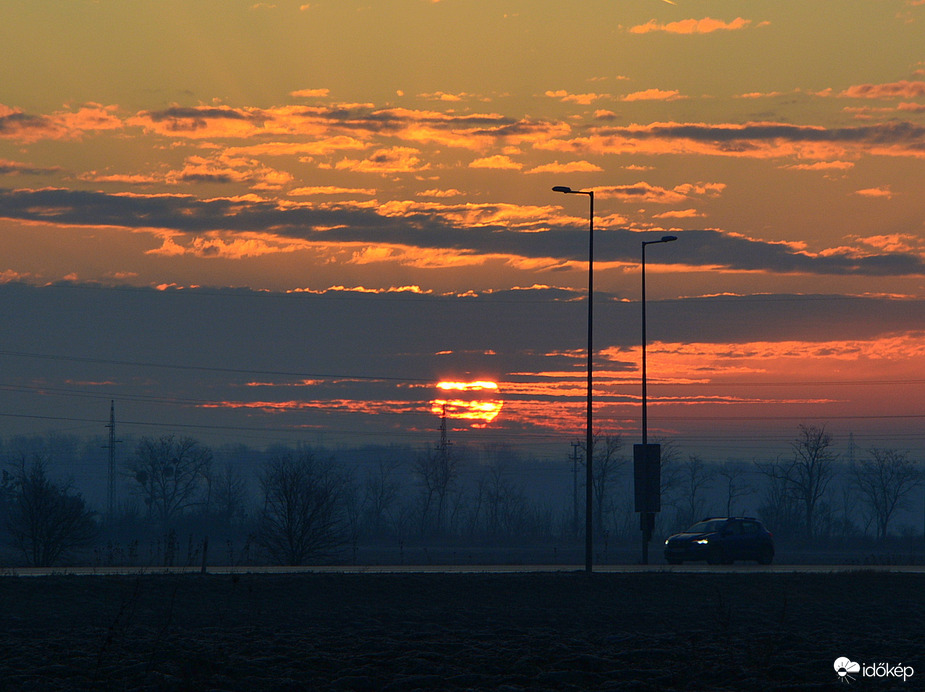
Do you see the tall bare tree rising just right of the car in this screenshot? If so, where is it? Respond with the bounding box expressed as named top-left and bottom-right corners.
top-left (758, 425), bottom-right (838, 539)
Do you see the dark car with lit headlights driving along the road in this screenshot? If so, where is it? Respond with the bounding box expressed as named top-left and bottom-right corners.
top-left (665, 517), bottom-right (774, 565)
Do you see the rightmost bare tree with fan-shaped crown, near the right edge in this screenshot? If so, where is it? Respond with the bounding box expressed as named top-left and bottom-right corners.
top-left (852, 449), bottom-right (922, 540)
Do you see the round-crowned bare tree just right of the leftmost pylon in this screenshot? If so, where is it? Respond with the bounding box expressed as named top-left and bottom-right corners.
top-left (129, 435), bottom-right (212, 534)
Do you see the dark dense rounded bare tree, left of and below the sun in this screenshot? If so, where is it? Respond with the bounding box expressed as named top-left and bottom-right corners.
top-left (256, 452), bottom-right (348, 565)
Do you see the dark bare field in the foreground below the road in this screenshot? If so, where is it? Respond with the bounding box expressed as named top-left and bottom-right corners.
top-left (0, 572), bottom-right (925, 690)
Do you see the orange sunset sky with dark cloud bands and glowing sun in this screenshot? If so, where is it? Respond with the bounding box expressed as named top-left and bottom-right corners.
top-left (0, 0), bottom-right (925, 460)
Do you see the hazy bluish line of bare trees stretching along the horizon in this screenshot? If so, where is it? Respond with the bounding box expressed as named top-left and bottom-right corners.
top-left (0, 425), bottom-right (923, 566)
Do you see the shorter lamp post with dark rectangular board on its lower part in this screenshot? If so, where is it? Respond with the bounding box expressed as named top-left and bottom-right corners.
top-left (633, 235), bottom-right (678, 565)
